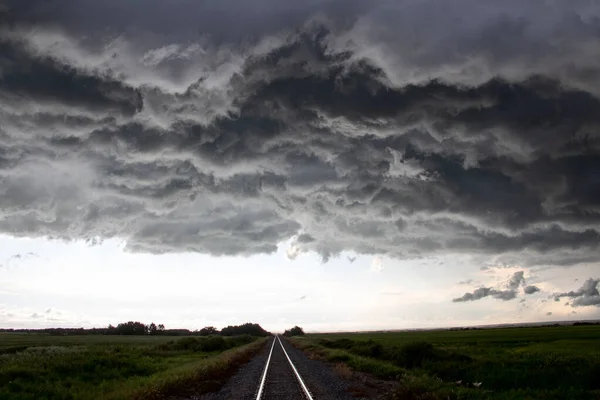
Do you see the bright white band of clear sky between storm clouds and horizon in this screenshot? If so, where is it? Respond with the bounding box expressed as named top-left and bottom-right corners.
top-left (0, 236), bottom-right (599, 331)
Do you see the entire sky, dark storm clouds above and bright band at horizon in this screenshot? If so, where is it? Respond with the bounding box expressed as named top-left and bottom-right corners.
top-left (0, 0), bottom-right (600, 331)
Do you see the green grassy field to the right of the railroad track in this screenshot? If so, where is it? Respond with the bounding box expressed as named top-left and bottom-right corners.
top-left (293, 326), bottom-right (600, 400)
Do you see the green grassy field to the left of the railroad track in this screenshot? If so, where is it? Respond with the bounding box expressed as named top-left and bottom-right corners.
top-left (0, 333), bottom-right (266, 400)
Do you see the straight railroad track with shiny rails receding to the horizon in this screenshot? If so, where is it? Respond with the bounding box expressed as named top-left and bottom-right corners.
top-left (256, 336), bottom-right (314, 400)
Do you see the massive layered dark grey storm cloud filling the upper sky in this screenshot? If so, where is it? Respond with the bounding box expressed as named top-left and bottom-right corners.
top-left (0, 0), bottom-right (600, 266)
